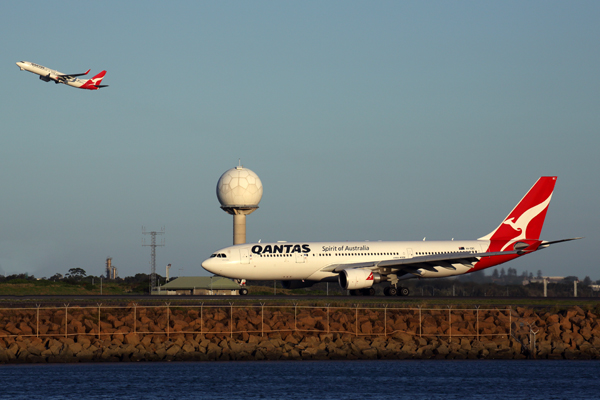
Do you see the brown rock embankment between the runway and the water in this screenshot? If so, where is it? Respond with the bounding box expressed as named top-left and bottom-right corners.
top-left (0, 306), bottom-right (600, 363)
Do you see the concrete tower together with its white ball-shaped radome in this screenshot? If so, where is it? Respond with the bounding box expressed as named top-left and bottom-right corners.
top-left (217, 165), bottom-right (262, 244)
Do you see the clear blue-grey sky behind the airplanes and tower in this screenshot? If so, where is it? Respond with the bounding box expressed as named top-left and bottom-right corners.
top-left (0, 0), bottom-right (600, 280)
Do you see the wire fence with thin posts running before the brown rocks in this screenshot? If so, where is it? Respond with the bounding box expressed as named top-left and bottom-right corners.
top-left (0, 303), bottom-right (513, 340)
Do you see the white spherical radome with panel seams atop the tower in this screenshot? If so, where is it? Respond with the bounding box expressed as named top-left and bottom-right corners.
top-left (217, 166), bottom-right (263, 207)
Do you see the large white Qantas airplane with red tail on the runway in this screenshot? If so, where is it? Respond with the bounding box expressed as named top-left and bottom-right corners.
top-left (202, 176), bottom-right (581, 296)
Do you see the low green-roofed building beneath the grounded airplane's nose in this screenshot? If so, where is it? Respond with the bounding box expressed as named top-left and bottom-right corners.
top-left (152, 276), bottom-right (240, 296)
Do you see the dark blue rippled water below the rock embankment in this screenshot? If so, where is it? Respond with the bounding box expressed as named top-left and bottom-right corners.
top-left (0, 360), bottom-right (600, 400)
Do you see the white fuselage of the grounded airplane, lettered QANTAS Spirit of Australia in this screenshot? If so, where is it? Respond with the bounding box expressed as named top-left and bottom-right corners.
top-left (202, 240), bottom-right (519, 281)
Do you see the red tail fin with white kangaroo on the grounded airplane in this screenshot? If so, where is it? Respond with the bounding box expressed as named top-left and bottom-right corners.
top-left (479, 176), bottom-right (556, 241)
